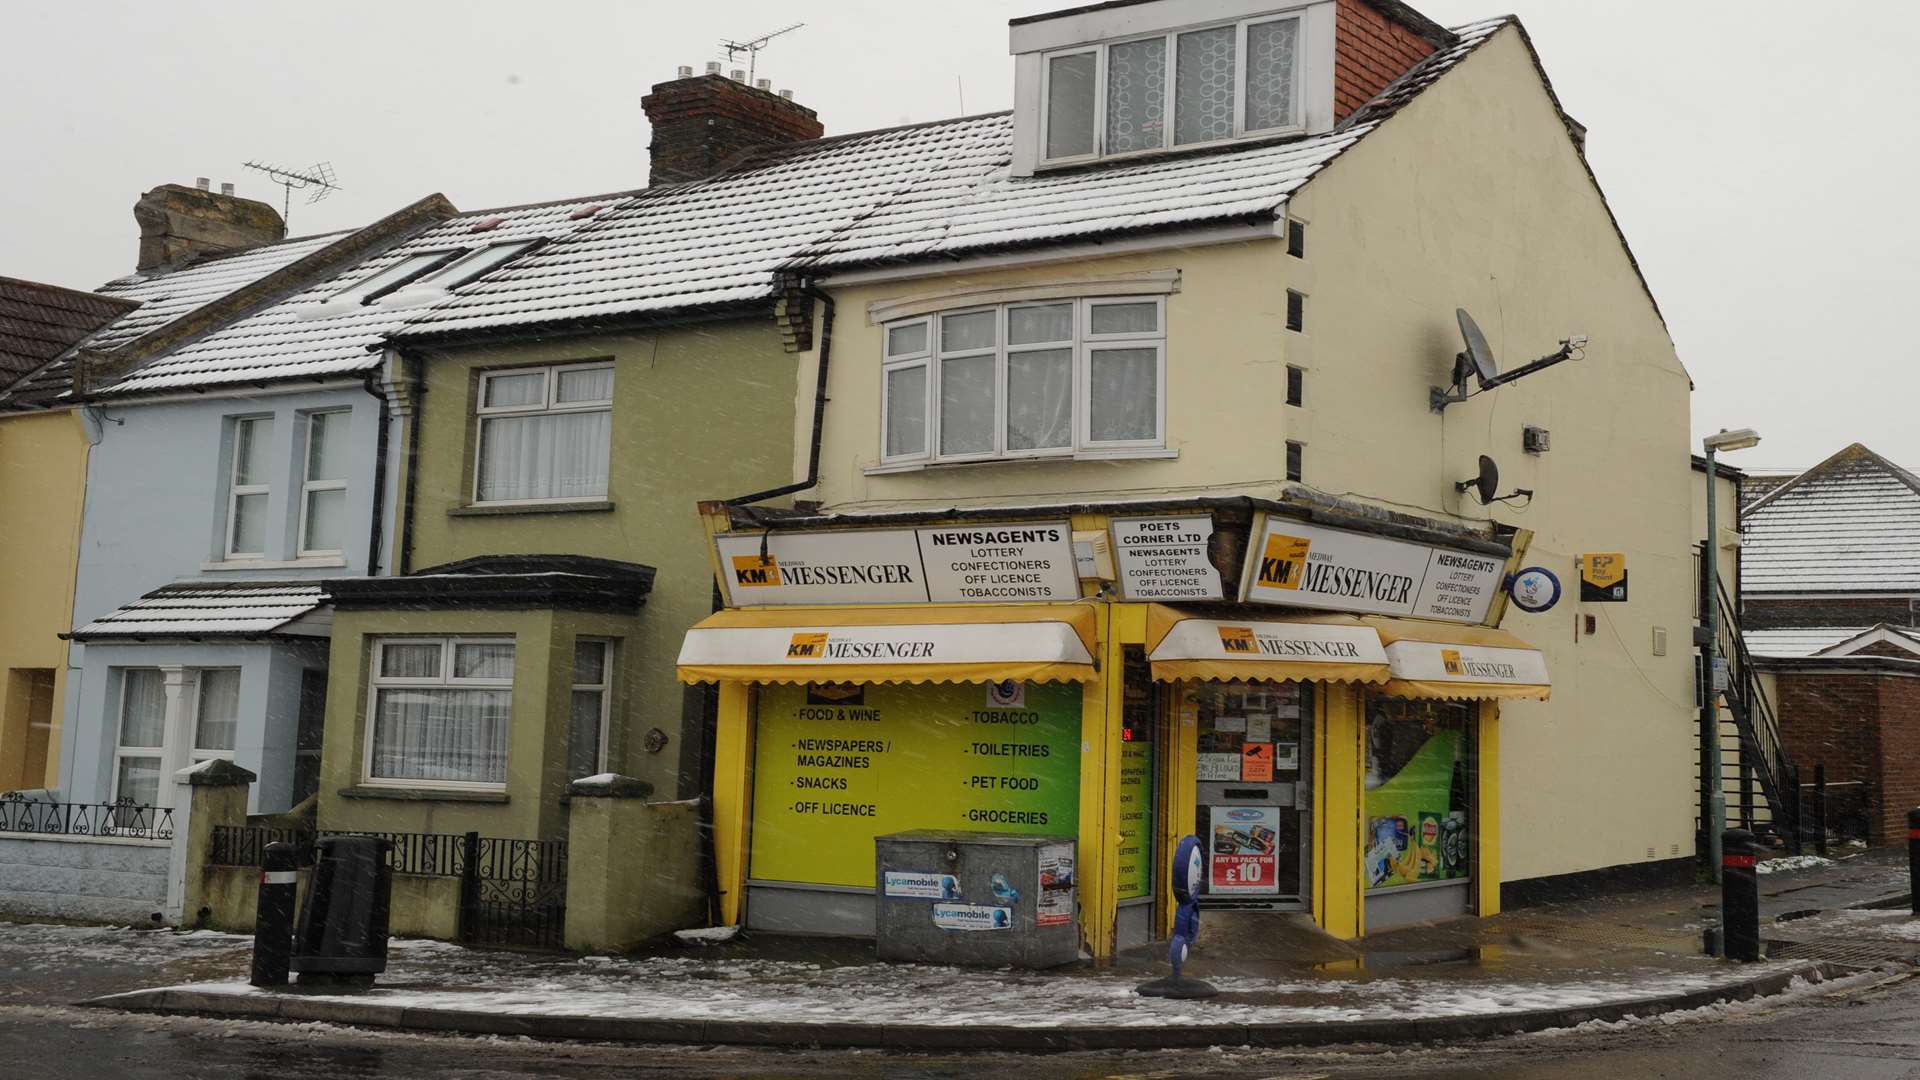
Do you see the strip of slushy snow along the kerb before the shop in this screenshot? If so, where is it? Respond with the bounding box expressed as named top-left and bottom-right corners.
top-left (127, 957), bottom-right (1788, 1028)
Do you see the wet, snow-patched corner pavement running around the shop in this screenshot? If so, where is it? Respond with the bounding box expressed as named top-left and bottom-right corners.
top-left (71, 851), bottom-right (1920, 1051)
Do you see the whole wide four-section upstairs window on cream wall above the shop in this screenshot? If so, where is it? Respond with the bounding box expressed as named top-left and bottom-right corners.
top-left (881, 296), bottom-right (1165, 463)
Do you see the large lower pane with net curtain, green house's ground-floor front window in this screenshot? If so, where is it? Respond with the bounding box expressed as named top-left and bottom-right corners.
top-left (372, 686), bottom-right (513, 784)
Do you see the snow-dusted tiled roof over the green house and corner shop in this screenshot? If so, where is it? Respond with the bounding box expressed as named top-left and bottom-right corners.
top-left (397, 19), bottom-right (1509, 338)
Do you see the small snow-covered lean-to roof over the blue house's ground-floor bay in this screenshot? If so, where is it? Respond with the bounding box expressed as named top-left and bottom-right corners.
top-left (71, 582), bottom-right (326, 642)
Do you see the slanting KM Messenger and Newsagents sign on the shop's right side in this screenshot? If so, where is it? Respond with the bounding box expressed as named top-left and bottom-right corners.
top-left (1240, 515), bottom-right (1505, 623)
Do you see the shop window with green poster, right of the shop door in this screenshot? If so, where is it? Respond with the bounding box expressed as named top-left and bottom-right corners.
top-left (1363, 696), bottom-right (1475, 890)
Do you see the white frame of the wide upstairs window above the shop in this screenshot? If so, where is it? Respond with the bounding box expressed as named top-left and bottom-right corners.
top-left (879, 294), bottom-right (1167, 467)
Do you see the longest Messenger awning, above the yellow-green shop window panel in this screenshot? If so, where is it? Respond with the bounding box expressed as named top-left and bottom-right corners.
top-left (680, 603), bottom-right (1098, 682)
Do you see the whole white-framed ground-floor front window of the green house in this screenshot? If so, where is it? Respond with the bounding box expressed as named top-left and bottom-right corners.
top-left (367, 638), bottom-right (515, 790)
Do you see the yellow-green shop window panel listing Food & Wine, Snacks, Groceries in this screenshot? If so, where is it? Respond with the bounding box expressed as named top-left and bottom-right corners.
top-left (751, 682), bottom-right (1081, 883)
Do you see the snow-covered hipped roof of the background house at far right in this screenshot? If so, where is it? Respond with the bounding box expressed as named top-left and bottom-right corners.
top-left (1740, 444), bottom-right (1920, 596)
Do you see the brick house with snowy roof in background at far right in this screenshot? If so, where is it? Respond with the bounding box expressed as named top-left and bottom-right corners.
top-left (1740, 442), bottom-right (1920, 844)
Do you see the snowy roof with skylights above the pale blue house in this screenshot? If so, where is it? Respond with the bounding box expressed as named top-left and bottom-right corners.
top-left (100, 196), bottom-right (622, 394)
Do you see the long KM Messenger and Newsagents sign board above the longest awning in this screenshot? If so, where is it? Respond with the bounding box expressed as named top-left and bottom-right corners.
top-left (714, 521), bottom-right (1079, 607)
